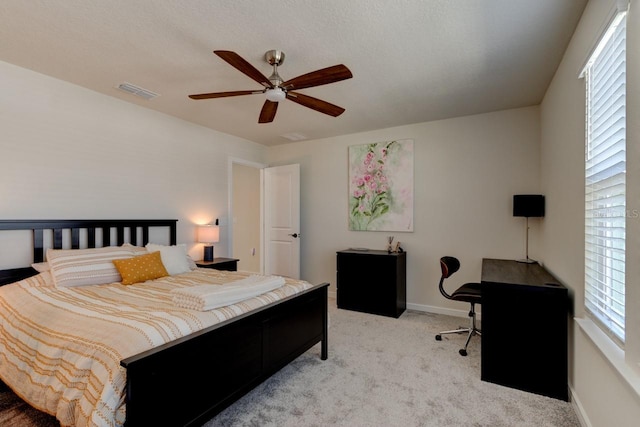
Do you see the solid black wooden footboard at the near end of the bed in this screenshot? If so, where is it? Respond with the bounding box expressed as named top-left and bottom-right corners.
top-left (121, 283), bottom-right (329, 427)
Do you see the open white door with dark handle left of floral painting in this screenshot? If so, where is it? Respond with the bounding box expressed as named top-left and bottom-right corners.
top-left (263, 164), bottom-right (300, 279)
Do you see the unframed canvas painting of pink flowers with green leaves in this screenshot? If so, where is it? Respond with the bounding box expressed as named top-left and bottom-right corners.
top-left (349, 139), bottom-right (413, 231)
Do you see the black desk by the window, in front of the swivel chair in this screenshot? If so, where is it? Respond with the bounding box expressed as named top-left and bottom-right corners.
top-left (481, 259), bottom-right (569, 401)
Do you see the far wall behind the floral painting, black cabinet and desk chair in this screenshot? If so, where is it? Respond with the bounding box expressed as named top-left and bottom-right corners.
top-left (268, 107), bottom-right (540, 314)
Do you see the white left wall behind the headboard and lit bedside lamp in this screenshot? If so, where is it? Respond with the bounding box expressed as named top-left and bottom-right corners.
top-left (0, 62), bottom-right (266, 268)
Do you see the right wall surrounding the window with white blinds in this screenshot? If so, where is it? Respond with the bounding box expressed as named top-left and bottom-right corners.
top-left (540, 0), bottom-right (640, 427)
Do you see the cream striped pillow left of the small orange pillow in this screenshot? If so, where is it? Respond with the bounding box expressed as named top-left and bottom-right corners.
top-left (47, 246), bottom-right (134, 286)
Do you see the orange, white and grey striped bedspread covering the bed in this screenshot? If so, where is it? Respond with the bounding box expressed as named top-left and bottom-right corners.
top-left (0, 269), bottom-right (312, 426)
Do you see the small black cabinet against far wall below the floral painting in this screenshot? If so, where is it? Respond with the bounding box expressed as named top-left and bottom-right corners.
top-left (337, 249), bottom-right (407, 318)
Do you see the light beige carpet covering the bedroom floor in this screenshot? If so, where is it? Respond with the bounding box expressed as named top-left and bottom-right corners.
top-left (0, 301), bottom-right (580, 427)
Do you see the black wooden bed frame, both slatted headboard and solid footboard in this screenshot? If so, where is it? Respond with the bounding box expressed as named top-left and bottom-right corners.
top-left (0, 219), bottom-right (329, 427)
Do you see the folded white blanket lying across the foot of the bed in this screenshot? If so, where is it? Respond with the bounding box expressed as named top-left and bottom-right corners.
top-left (171, 275), bottom-right (284, 311)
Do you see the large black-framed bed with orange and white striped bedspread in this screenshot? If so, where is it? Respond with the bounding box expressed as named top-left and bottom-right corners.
top-left (0, 220), bottom-right (328, 427)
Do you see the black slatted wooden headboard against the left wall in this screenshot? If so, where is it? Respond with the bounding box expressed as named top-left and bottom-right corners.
top-left (0, 219), bottom-right (178, 286)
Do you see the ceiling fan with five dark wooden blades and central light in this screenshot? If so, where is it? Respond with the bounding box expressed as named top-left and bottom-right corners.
top-left (189, 50), bottom-right (353, 123)
